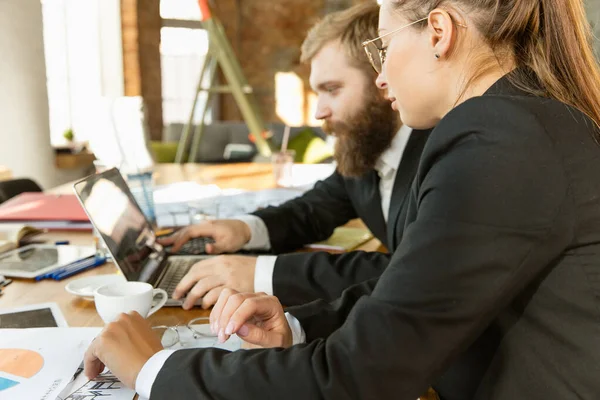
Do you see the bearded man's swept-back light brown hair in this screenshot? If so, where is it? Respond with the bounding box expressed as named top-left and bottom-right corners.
top-left (300, 1), bottom-right (379, 74)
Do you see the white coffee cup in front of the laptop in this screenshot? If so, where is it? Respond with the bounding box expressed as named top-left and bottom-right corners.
top-left (94, 282), bottom-right (168, 324)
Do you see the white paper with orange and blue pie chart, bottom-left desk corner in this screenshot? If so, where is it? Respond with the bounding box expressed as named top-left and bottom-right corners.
top-left (0, 328), bottom-right (100, 400)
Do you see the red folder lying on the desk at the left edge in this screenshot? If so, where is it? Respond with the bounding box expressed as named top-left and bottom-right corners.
top-left (0, 193), bottom-right (89, 222)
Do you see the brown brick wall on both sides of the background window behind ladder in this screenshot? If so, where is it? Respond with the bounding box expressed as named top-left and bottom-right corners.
top-left (121, 0), bottom-right (374, 140)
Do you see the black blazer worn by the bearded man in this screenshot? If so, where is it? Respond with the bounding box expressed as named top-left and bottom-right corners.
top-left (254, 131), bottom-right (430, 306)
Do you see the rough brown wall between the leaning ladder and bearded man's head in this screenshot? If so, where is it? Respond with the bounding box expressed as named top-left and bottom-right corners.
top-left (213, 0), bottom-right (369, 122)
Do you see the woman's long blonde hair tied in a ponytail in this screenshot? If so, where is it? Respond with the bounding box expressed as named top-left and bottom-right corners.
top-left (392, 0), bottom-right (600, 131)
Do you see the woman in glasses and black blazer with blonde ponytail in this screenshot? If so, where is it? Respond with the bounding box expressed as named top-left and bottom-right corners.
top-left (86, 0), bottom-right (600, 400)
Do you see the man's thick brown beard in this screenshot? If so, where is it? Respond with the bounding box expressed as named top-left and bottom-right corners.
top-left (323, 91), bottom-right (400, 177)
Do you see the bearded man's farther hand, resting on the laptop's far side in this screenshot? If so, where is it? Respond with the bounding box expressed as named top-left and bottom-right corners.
top-left (158, 219), bottom-right (251, 254)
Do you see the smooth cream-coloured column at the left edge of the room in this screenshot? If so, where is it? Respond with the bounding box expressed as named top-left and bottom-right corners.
top-left (0, 0), bottom-right (82, 188)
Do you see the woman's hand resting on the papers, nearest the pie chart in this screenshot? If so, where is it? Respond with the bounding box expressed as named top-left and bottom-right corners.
top-left (83, 311), bottom-right (163, 389)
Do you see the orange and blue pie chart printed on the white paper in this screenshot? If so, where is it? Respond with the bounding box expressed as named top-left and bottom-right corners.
top-left (0, 349), bottom-right (44, 392)
